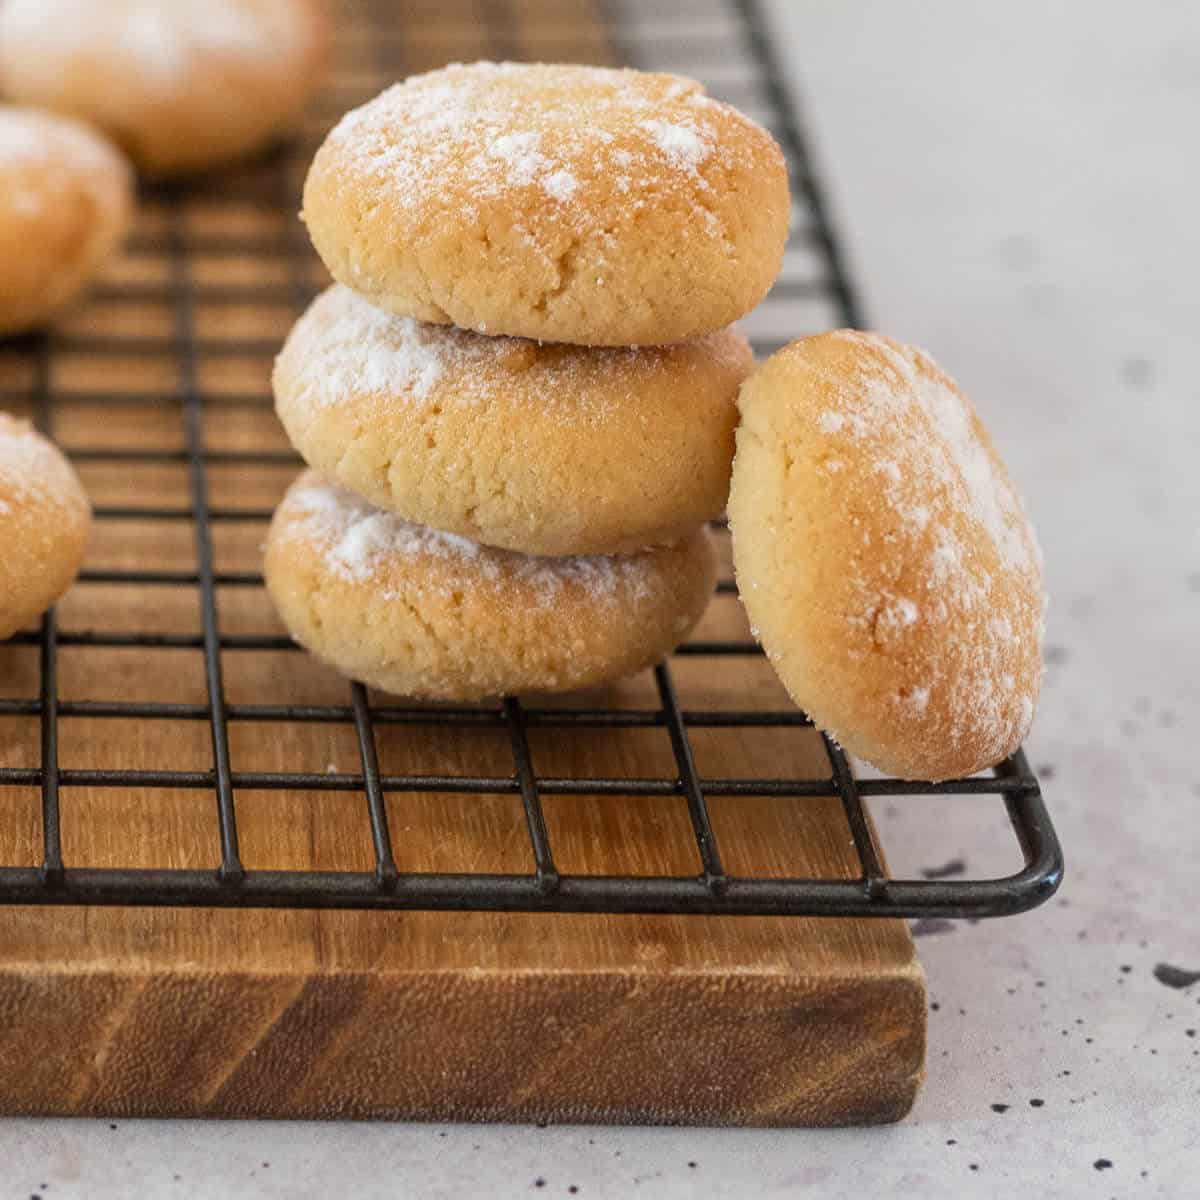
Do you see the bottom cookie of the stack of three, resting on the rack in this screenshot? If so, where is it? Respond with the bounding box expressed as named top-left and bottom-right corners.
top-left (266, 472), bottom-right (716, 700)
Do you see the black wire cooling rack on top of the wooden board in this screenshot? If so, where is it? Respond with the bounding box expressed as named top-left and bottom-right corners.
top-left (0, 0), bottom-right (1062, 917)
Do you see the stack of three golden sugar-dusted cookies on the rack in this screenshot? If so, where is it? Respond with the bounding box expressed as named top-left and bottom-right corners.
top-left (266, 62), bottom-right (788, 700)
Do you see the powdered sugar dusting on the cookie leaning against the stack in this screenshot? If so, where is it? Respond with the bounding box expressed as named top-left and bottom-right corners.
top-left (810, 330), bottom-right (1045, 757)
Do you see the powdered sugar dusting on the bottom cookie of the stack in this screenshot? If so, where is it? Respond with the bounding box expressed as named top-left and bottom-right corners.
top-left (282, 474), bottom-right (654, 606)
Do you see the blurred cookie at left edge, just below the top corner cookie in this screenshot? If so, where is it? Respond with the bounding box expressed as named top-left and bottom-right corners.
top-left (0, 107), bottom-right (133, 335)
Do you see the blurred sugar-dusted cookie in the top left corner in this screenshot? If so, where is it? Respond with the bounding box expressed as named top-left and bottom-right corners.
top-left (0, 0), bottom-right (329, 176)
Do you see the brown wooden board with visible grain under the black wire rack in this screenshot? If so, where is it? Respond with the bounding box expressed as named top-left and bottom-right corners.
top-left (0, 4), bottom-right (925, 1124)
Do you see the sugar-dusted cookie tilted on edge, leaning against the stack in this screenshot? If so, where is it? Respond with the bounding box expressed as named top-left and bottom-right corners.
top-left (728, 330), bottom-right (1045, 780)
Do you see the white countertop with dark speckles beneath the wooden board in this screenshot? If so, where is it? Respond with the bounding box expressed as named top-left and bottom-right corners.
top-left (0, 0), bottom-right (1200, 1200)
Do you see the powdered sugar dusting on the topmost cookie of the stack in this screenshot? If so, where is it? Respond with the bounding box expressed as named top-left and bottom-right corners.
top-left (314, 62), bottom-right (757, 234)
